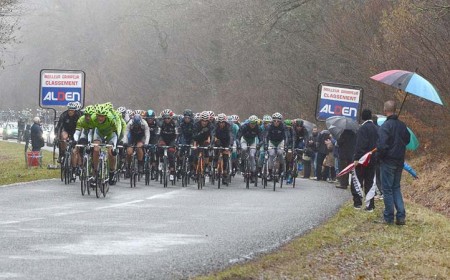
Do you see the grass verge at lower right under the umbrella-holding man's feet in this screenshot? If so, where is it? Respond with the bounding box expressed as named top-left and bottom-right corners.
top-left (197, 201), bottom-right (450, 280)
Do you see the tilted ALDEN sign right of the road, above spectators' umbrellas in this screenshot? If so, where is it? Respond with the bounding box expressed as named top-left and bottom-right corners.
top-left (316, 82), bottom-right (363, 121)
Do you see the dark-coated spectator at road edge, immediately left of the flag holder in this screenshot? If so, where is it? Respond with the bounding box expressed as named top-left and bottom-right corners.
top-left (336, 129), bottom-right (356, 189)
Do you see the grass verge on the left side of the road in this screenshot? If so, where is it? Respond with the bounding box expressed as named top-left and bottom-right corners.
top-left (0, 141), bottom-right (60, 186)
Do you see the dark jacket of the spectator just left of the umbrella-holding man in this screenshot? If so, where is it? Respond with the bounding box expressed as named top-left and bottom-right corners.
top-left (353, 121), bottom-right (378, 164)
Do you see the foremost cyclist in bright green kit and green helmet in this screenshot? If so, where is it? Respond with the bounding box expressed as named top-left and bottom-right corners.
top-left (92, 103), bottom-right (122, 185)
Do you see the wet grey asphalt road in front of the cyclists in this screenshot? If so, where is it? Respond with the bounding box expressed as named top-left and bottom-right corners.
top-left (0, 173), bottom-right (350, 279)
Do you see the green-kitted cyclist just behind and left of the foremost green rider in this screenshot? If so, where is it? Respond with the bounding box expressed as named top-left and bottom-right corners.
top-left (72, 105), bottom-right (95, 179)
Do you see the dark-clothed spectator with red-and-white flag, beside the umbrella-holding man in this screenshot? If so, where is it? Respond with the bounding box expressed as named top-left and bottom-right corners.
top-left (351, 109), bottom-right (378, 212)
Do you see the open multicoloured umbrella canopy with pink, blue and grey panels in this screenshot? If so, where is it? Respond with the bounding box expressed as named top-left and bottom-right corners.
top-left (370, 70), bottom-right (443, 105)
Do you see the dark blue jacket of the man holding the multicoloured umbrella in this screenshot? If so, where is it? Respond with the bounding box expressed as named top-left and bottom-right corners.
top-left (377, 115), bottom-right (411, 167)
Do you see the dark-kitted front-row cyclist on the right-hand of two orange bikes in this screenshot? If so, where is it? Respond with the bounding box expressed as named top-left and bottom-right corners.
top-left (214, 114), bottom-right (233, 185)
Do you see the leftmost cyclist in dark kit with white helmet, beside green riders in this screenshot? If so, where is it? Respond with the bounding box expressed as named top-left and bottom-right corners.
top-left (55, 102), bottom-right (81, 163)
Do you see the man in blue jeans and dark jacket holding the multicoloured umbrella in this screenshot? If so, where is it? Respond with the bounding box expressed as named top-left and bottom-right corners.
top-left (377, 100), bottom-right (410, 225)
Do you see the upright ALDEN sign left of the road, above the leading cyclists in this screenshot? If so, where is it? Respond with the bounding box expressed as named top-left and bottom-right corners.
top-left (39, 69), bottom-right (85, 108)
